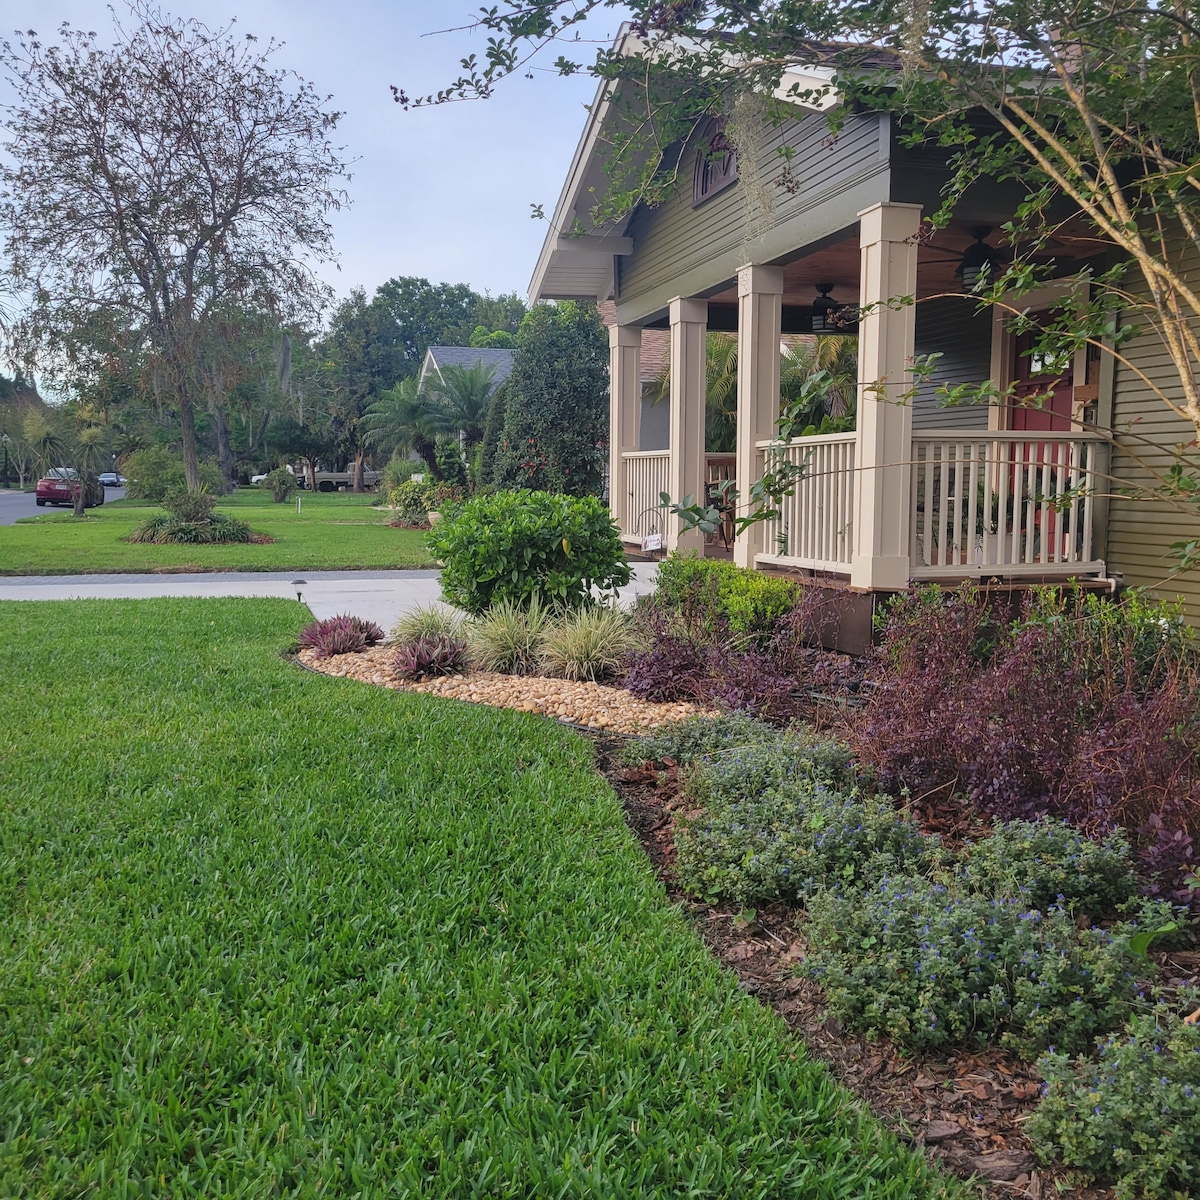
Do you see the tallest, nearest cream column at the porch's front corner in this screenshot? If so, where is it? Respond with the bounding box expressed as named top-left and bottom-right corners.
top-left (850, 204), bottom-right (920, 589)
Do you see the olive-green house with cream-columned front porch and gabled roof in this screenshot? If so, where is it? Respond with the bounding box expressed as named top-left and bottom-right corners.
top-left (530, 35), bottom-right (1200, 618)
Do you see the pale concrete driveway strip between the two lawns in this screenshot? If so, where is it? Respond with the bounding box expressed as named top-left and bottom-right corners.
top-left (0, 563), bottom-right (658, 630)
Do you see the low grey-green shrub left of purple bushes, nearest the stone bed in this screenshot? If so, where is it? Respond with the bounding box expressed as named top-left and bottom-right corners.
top-left (676, 737), bottom-right (937, 905)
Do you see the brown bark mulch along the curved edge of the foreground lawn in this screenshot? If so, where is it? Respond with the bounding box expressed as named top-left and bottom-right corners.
top-left (598, 739), bottom-right (1200, 1200)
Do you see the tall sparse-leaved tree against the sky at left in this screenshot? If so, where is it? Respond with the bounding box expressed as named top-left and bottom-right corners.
top-left (0, 0), bottom-right (344, 490)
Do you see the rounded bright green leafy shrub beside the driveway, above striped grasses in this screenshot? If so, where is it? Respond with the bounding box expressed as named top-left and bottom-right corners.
top-left (427, 492), bottom-right (630, 613)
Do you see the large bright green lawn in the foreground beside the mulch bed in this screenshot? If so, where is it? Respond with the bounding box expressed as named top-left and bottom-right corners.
top-left (0, 600), bottom-right (954, 1198)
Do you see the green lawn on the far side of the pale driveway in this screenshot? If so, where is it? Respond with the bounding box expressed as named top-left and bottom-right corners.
top-left (0, 488), bottom-right (431, 575)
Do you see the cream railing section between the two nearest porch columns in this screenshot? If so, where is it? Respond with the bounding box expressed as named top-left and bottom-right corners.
top-left (757, 433), bottom-right (857, 572)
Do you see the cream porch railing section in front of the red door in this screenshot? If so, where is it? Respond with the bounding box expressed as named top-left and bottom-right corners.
top-left (912, 431), bottom-right (1108, 580)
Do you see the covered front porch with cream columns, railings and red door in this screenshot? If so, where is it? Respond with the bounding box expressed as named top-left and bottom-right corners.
top-left (610, 203), bottom-right (1109, 592)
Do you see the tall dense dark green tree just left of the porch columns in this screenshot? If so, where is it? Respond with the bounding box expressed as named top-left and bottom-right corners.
top-left (494, 301), bottom-right (608, 496)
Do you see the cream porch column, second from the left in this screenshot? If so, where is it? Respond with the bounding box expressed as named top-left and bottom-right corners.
top-left (667, 298), bottom-right (708, 552)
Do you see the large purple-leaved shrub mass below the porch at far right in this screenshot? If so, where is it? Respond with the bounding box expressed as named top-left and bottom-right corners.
top-left (854, 589), bottom-right (1200, 899)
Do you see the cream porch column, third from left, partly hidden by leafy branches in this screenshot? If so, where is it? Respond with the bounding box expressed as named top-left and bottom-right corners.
top-left (733, 266), bottom-right (784, 566)
